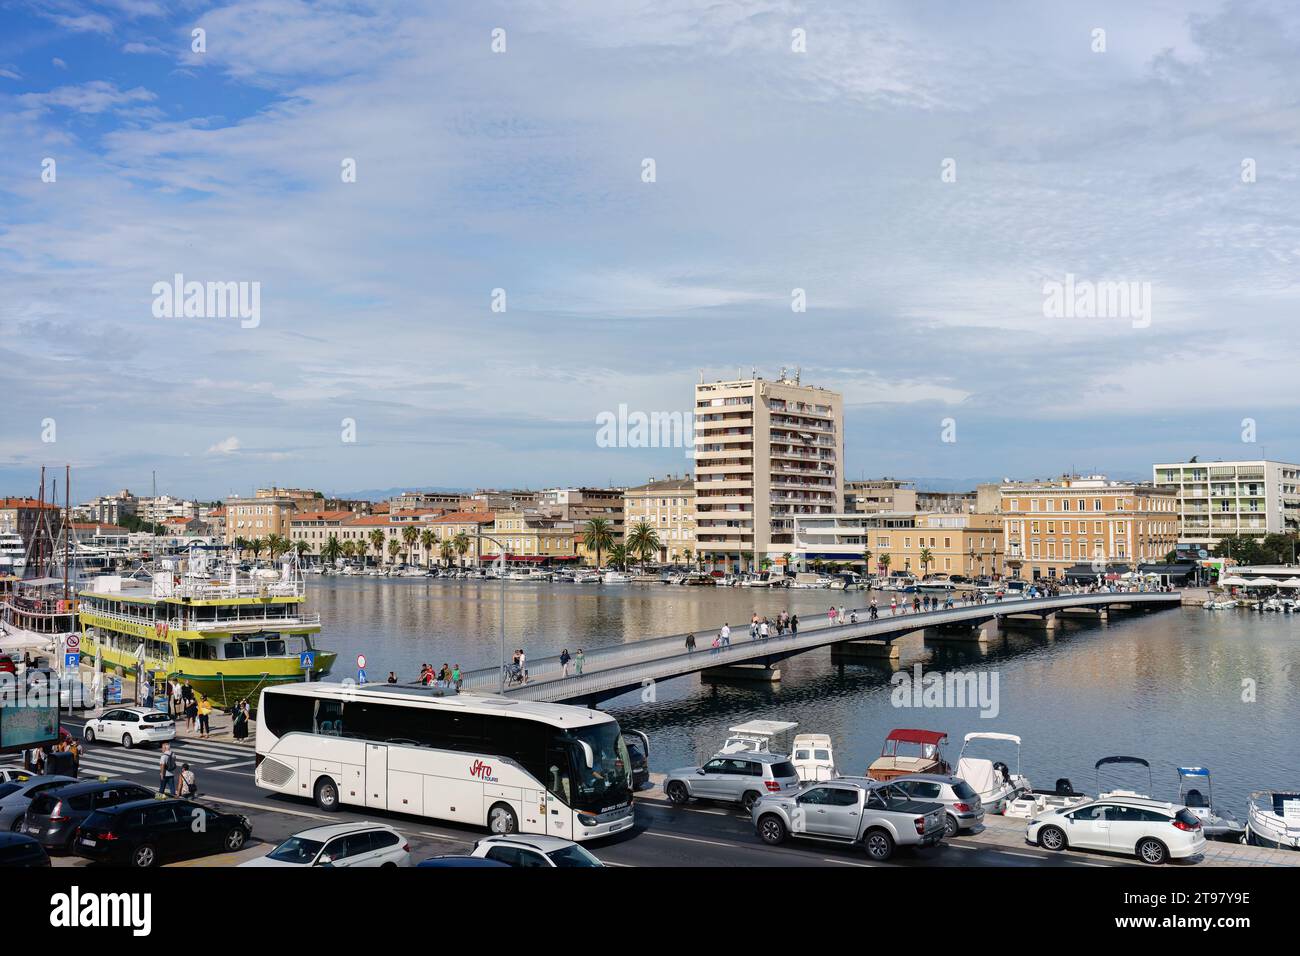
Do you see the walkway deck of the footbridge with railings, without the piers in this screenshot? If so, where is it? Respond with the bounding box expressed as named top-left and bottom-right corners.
top-left (449, 592), bottom-right (1182, 702)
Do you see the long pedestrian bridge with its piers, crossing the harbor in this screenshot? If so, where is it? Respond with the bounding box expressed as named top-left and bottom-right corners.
top-left (462, 592), bottom-right (1182, 704)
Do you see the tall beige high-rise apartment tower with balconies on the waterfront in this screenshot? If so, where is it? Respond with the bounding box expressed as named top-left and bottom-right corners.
top-left (694, 369), bottom-right (844, 570)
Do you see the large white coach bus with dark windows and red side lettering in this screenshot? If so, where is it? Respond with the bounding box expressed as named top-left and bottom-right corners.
top-left (255, 683), bottom-right (633, 840)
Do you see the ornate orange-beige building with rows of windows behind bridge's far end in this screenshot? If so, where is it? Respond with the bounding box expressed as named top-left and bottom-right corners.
top-left (1001, 475), bottom-right (1178, 580)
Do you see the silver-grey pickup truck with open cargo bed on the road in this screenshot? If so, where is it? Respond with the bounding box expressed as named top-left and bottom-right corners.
top-left (751, 777), bottom-right (946, 862)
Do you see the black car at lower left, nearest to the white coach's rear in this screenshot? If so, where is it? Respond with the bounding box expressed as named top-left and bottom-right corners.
top-left (73, 797), bottom-right (252, 866)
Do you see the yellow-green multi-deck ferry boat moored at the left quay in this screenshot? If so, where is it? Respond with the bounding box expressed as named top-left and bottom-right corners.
top-left (78, 553), bottom-right (335, 706)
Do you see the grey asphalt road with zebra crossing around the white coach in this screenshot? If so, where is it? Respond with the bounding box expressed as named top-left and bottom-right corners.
top-left (25, 718), bottom-right (1140, 868)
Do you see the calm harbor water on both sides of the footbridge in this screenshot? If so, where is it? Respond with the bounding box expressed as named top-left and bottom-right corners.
top-left (308, 578), bottom-right (1300, 818)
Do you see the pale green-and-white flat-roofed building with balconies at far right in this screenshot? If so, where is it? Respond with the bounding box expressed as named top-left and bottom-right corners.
top-left (1152, 459), bottom-right (1300, 550)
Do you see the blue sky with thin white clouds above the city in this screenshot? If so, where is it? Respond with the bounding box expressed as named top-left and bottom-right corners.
top-left (0, 0), bottom-right (1300, 498)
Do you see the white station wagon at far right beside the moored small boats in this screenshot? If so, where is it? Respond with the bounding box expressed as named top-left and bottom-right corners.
top-left (1024, 796), bottom-right (1205, 864)
